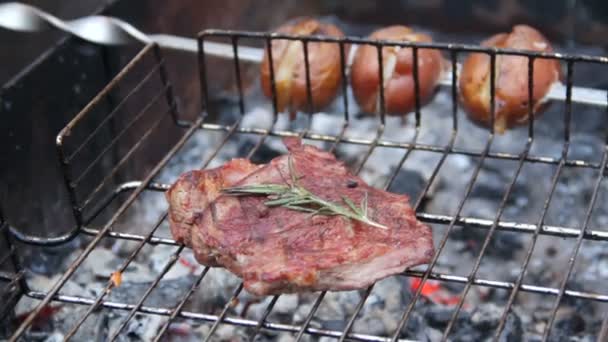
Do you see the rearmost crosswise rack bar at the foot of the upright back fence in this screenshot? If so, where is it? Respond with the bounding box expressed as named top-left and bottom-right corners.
top-left (201, 123), bottom-right (599, 169)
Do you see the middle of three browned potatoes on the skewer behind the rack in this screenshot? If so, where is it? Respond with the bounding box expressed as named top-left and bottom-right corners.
top-left (351, 26), bottom-right (442, 115)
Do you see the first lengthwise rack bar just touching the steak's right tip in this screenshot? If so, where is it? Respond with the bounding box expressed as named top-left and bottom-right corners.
top-left (392, 134), bottom-right (494, 341)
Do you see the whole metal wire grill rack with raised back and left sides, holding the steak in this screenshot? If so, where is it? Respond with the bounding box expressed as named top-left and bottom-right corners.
top-left (0, 30), bottom-right (608, 341)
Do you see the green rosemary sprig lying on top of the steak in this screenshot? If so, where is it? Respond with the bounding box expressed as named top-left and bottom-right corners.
top-left (222, 157), bottom-right (388, 229)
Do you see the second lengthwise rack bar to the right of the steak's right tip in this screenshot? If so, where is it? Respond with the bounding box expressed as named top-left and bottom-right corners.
top-left (443, 139), bottom-right (532, 340)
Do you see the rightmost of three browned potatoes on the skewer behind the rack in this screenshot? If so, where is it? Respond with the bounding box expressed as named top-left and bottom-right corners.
top-left (459, 25), bottom-right (560, 133)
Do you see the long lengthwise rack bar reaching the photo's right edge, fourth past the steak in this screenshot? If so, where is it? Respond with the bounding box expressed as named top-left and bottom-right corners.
top-left (543, 152), bottom-right (608, 341)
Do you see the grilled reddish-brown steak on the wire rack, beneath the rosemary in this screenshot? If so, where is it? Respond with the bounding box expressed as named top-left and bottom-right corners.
top-left (167, 138), bottom-right (433, 295)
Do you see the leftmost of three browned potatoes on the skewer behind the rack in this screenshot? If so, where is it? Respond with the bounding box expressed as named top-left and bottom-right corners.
top-left (261, 18), bottom-right (348, 117)
